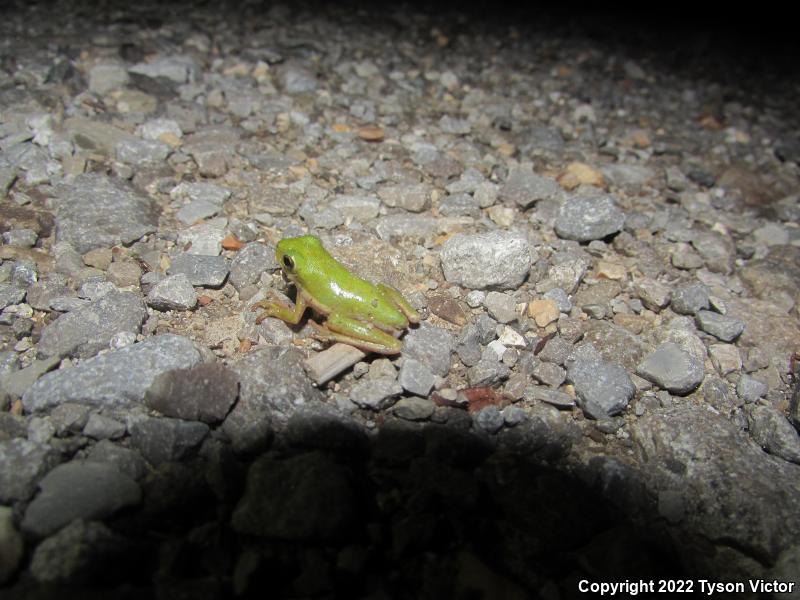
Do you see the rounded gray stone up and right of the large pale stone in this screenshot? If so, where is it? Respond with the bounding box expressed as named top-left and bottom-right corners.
top-left (555, 194), bottom-right (625, 242)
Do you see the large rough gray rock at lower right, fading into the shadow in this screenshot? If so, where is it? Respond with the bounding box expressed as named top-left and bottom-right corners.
top-left (630, 403), bottom-right (800, 568)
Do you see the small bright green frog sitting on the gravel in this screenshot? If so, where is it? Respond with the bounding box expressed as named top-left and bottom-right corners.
top-left (253, 235), bottom-right (419, 354)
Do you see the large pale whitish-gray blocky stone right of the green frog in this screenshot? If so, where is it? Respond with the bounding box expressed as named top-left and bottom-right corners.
top-left (441, 230), bottom-right (531, 289)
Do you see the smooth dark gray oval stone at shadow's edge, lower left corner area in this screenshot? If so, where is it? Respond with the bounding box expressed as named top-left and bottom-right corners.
top-left (22, 461), bottom-right (142, 537)
